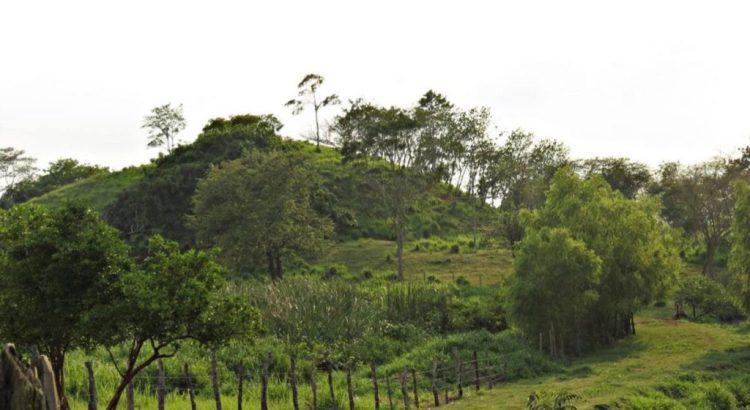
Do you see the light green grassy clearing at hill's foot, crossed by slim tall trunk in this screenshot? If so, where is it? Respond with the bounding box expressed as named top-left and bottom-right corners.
top-left (317, 239), bottom-right (513, 285)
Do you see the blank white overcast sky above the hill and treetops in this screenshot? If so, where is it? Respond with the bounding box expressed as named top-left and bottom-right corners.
top-left (0, 0), bottom-right (750, 169)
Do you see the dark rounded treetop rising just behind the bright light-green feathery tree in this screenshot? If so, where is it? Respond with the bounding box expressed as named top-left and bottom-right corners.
top-left (578, 158), bottom-right (651, 199)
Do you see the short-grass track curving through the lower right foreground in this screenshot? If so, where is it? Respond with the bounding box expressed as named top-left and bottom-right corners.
top-left (449, 308), bottom-right (750, 409)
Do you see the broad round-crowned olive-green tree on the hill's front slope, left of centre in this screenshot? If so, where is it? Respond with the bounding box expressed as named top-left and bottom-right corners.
top-left (191, 151), bottom-right (333, 280)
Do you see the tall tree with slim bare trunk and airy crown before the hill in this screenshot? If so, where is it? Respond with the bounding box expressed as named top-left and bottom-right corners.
top-left (335, 95), bottom-right (452, 279)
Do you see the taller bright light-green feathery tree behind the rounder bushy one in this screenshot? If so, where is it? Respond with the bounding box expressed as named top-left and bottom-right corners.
top-left (521, 168), bottom-right (680, 345)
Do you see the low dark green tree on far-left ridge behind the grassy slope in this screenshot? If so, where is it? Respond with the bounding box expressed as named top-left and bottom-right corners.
top-left (0, 158), bottom-right (109, 208)
